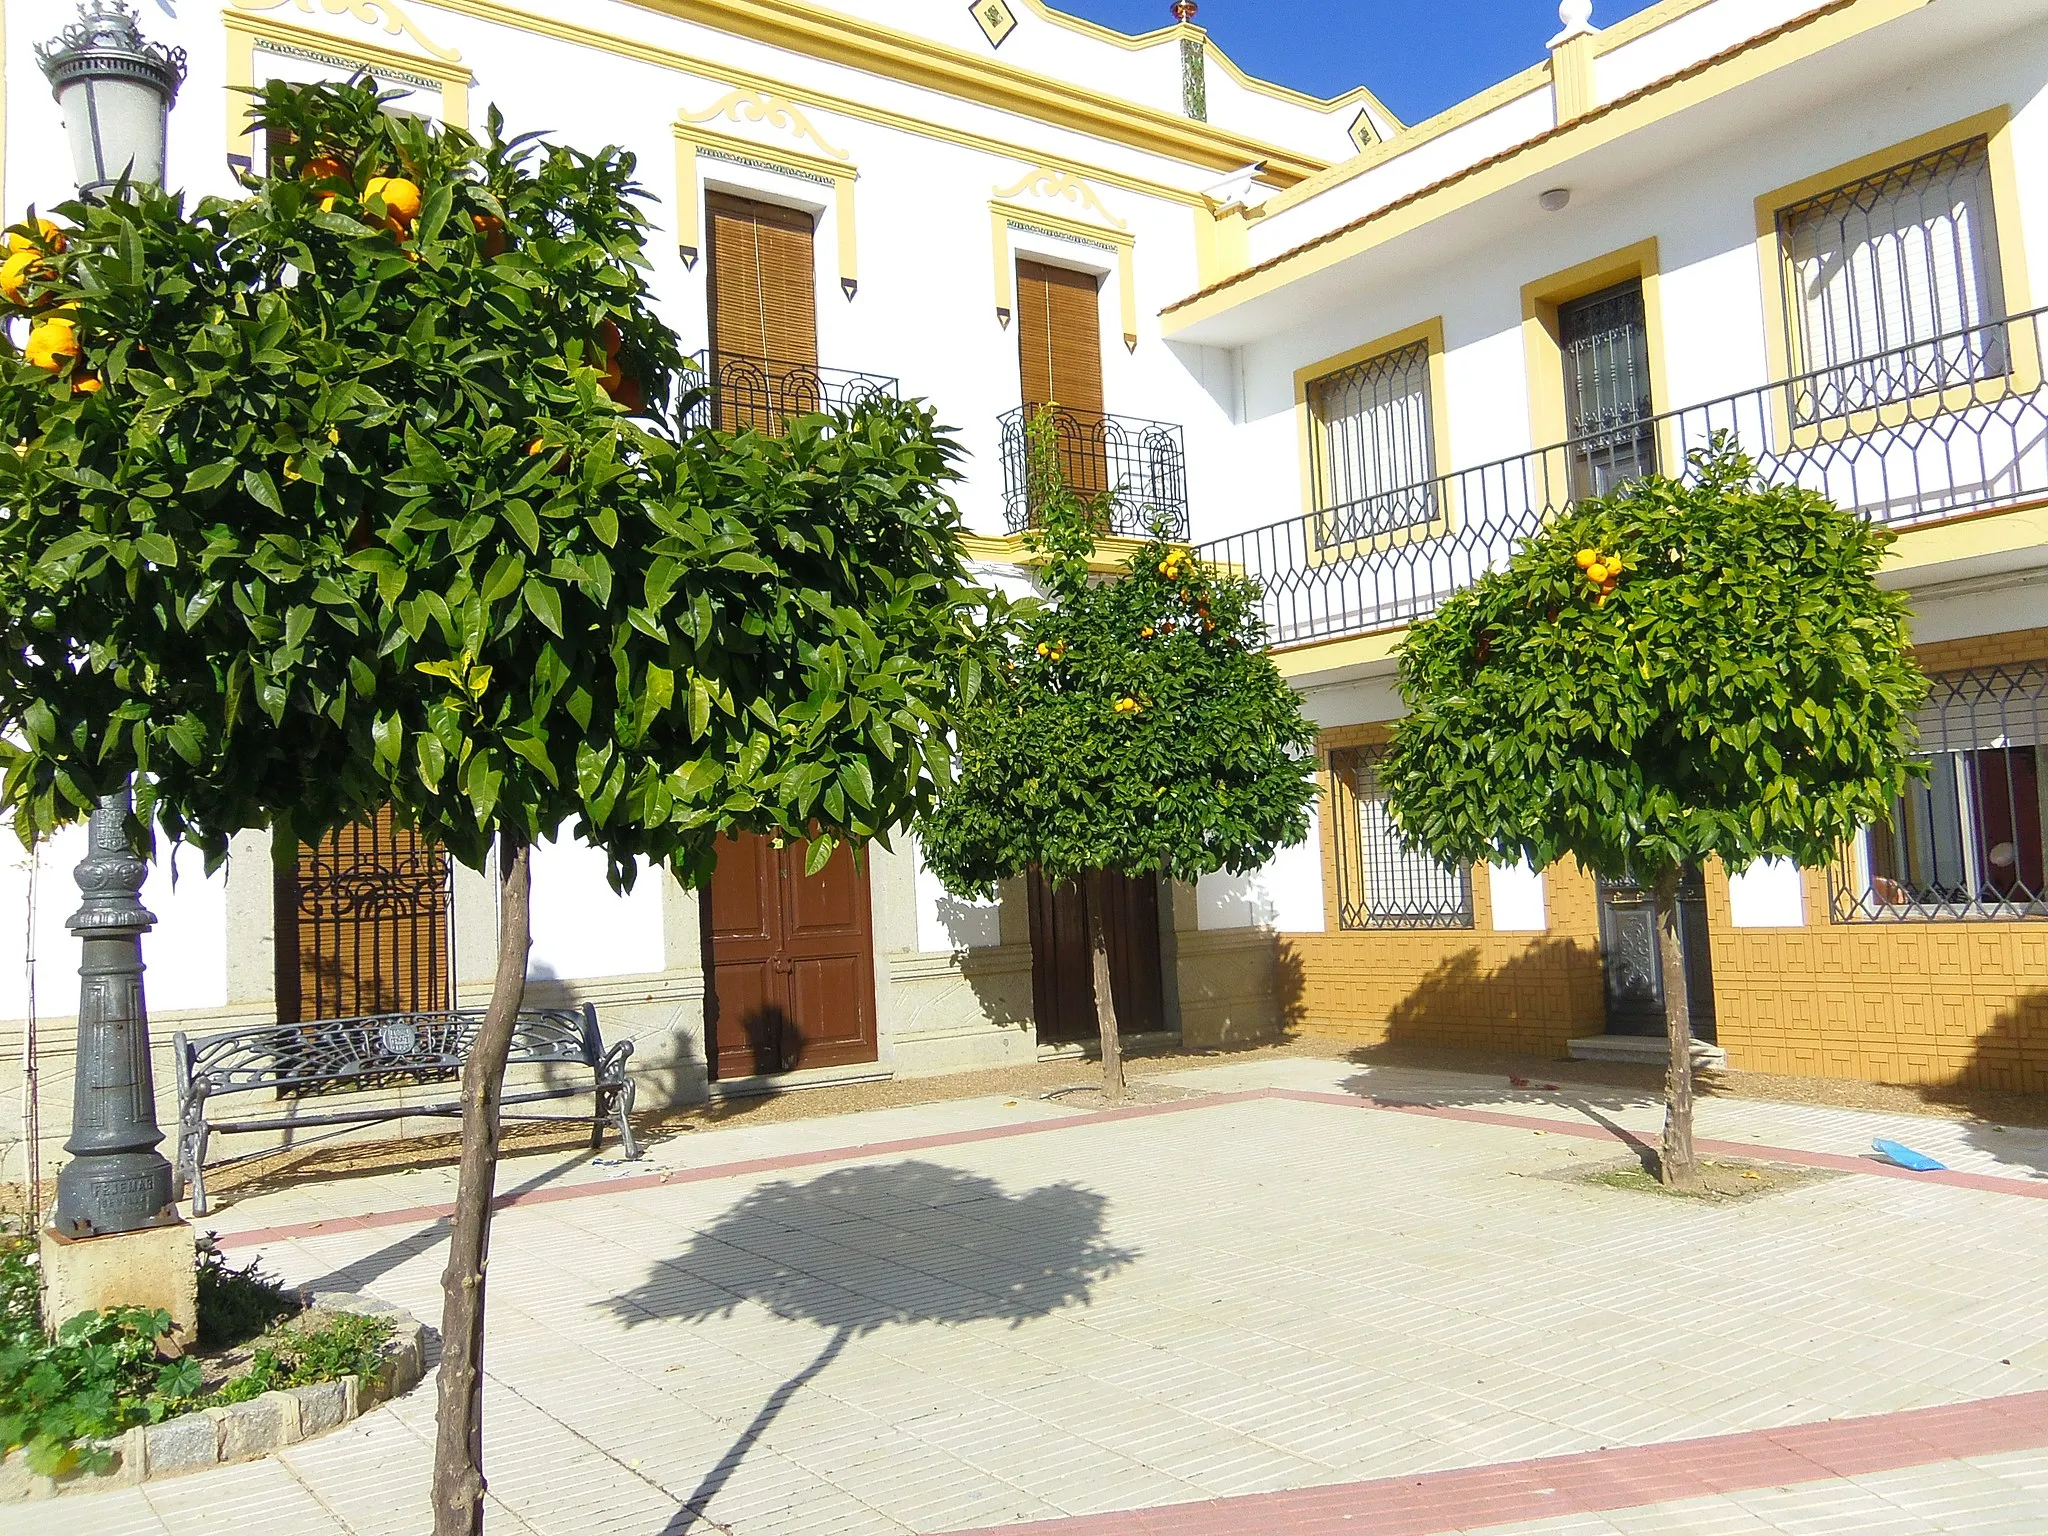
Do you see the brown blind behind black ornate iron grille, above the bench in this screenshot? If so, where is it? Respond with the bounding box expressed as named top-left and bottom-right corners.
top-left (276, 809), bottom-right (455, 1024)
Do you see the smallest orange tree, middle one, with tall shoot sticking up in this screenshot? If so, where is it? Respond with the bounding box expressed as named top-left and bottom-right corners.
top-left (918, 453), bottom-right (1315, 1102)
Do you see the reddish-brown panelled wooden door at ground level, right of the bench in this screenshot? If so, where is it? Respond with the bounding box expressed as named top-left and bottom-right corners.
top-left (705, 834), bottom-right (877, 1079)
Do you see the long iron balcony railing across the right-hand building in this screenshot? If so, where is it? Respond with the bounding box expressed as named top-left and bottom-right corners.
top-left (1200, 309), bottom-right (2048, 645)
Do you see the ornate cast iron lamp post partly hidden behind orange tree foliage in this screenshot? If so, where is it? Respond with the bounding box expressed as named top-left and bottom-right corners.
top-left (35, 0), bottom-right (184, 1237)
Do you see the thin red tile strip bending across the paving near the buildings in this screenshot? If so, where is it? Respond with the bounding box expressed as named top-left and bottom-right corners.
top-left (219, 1087), bottom-right (2048, 1247)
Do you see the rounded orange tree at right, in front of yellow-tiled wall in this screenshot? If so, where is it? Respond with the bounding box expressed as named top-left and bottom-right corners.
top-left (1380, 438), bottom-right (1927, 1188)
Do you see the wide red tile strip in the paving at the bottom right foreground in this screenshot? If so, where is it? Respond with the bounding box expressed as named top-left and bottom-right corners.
top-left (929, 1393), bottom-right (2048, 1536)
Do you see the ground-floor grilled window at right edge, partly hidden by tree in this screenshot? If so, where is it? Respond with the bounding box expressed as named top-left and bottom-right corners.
top-left (1829, 666), bottom-right (2048, 924)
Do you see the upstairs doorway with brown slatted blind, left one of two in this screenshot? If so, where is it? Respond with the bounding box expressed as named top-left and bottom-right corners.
top-left (705, 193), bottom-right (821, 434)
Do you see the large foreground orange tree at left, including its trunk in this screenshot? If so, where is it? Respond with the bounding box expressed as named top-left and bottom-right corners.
top-left (0, 84), bottom-right (977, 1534)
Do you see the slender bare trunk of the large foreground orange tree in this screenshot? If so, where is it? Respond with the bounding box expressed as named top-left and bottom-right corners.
top-left (434, 834), bottom-right (532, 1536)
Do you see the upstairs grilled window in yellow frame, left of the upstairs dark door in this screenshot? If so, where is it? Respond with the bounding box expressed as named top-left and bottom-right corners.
top-left (1309, 342), bottom-right (1438, 547)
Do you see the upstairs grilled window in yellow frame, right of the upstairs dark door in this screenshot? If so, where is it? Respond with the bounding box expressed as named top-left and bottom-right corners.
top-left (1778, 139), bottom-right (2009, 420)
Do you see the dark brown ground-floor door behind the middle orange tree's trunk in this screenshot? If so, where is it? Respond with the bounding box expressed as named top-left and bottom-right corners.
top-left (1028, 872), bottom-right (1165, 1042)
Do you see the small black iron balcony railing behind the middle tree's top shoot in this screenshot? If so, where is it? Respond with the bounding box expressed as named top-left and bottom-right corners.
top-left (1001, 406), bottom-right (1188, 539)
